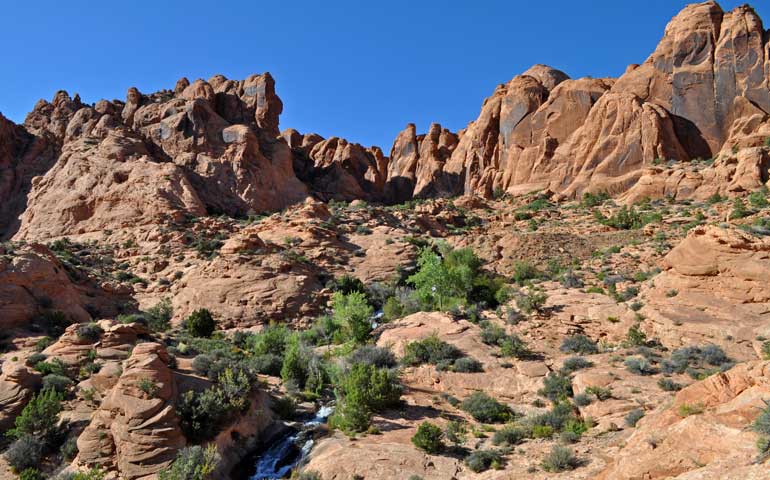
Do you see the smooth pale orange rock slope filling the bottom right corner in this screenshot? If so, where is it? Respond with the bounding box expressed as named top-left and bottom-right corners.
top-left (598, 362), bottom-right (770, 480)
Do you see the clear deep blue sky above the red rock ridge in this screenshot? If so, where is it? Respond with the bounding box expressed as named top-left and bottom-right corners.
top-left (0, 0), bottom-right (770, 150)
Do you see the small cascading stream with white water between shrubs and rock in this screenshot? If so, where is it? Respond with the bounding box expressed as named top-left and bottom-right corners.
top-left (248, 405), bottom-right (334, 480)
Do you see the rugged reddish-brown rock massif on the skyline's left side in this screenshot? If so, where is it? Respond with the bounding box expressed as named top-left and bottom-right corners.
top-left (11, 74), bottom-right (307, 239)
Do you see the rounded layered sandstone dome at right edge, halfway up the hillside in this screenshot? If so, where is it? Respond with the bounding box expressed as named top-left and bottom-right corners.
top-left (642, 226), bottom-right (770, 360)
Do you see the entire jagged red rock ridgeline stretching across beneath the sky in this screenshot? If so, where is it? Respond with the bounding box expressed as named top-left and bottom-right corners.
top-left (0, 2), bottom-right (770, 239)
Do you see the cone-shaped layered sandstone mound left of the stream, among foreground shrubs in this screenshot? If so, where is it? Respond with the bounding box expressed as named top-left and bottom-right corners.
top-left (75, 342), bottom-right (185, 480)
